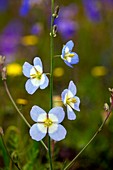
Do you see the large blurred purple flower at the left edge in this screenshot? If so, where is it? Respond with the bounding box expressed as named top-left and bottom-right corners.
top-left (0, 20), bottom-right (23, 60)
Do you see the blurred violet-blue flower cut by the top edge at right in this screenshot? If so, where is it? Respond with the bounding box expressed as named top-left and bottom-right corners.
top-left (83, 0), bottom-right (102, 22)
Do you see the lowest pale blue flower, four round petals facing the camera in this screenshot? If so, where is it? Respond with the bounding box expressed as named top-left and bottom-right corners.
top-left (30, 105), bottom-right (66, 141)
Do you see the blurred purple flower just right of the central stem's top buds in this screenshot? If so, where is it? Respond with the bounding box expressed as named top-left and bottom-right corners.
top-left (55, 4), bottom-right (78, 40)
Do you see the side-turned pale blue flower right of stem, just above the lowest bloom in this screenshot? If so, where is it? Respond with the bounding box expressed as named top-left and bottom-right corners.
top-left (61, 81), bottom-right (80, 120)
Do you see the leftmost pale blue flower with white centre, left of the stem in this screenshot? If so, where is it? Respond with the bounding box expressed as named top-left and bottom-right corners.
top-left (23, 57), bottom-right (49, 94)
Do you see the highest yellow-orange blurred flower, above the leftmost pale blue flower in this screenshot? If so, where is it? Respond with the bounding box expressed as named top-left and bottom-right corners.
top-left (21, 35), bottom-right (38, 46)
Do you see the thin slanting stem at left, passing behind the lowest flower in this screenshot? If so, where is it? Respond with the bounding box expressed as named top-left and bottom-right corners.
top-left (3, 80), bottom-right (48, 151)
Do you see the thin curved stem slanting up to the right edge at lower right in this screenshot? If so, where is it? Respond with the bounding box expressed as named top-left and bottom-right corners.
top-left (64, 104), bottom-right (113, 170)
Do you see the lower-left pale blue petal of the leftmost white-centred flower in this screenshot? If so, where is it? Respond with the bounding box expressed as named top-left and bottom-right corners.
top-left (25, 79), bottom-right (38, 94)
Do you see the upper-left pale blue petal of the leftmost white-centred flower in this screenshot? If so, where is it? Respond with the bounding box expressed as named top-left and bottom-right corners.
top-left (22, 62), bottom-right (33, 77)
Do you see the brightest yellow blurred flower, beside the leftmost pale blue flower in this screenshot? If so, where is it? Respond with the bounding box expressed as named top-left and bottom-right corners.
top-left (6, 63), bottom-right (22, 76)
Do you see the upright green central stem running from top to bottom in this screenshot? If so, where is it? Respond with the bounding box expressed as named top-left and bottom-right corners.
top-left (48, 0), bottom-right (54, 170)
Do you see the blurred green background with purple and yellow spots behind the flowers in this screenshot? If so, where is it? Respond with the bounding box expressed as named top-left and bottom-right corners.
top-left (0, 0), bottom-right (113, 170)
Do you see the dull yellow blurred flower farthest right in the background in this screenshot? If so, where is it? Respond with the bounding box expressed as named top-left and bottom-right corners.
top-left (91, 66), bottom-right (108, 77)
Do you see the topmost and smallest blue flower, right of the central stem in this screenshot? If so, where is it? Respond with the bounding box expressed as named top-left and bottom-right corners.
top-left (61, 40), bottom-right (79, 67)
